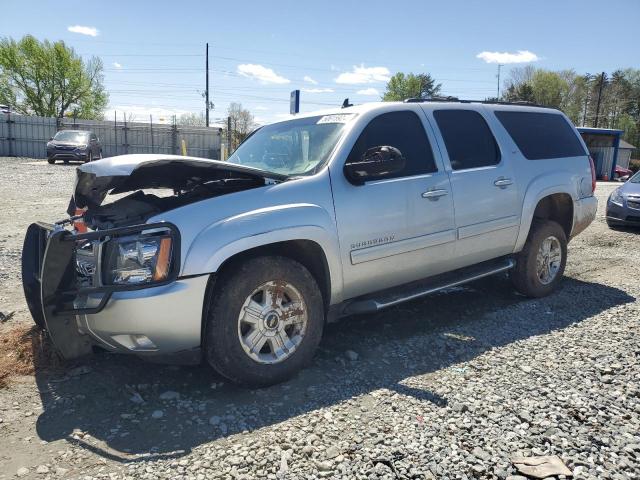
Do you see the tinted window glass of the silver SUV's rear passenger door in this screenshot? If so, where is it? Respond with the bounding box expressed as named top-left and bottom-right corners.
top-left (433, 110), bottom-right (500, 170)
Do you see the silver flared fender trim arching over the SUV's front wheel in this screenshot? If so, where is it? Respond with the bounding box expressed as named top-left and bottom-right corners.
top-left (181, 204), bottom-right (342, 303)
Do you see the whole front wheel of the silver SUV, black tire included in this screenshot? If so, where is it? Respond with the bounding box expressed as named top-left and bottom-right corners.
top-left (204, 256), bottom-right (325, 387)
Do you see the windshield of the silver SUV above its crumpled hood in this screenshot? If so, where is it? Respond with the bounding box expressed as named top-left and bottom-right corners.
top-left (229, 114), bottom-right (354, 176)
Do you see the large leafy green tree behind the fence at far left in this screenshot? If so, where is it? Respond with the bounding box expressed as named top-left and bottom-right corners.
top-left (0, 35), bottom-right (109, 119)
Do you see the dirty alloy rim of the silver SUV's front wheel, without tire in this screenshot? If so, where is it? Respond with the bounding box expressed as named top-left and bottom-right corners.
top-left (238, 281), bottom-right (308, 364)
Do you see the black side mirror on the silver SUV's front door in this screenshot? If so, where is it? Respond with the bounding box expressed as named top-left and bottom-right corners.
top-left (344, 145), bottom-right (406, 185)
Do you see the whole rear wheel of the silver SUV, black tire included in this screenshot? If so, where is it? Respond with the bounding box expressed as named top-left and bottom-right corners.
top-left (510, 220), bottom-right (567, 298)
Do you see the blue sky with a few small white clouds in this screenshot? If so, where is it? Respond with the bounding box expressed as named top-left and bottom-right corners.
top-left (0, 0), bottom-right (640, 123)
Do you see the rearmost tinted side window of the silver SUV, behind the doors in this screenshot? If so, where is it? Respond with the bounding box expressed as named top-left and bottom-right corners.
top-left (495, 111), bottom-right (587, 160)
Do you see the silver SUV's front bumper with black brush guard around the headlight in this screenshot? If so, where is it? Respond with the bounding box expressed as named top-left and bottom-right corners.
top-left (22, 223), bottom-right (209, 363)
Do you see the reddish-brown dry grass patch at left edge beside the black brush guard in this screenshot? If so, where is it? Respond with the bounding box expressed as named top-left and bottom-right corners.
top-left (0, 325), bottom-right (61, 388)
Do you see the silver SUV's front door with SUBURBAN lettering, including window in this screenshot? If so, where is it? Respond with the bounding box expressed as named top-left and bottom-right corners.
top-left (331, 105), bottom-right (456, 298)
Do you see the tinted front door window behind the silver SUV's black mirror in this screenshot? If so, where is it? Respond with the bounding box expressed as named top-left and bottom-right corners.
top-left (347, 112), bottom-right (437, 178)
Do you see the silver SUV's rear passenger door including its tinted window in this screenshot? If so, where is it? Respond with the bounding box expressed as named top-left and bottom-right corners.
top-left (429, 106), bottom-right (521, 266)
